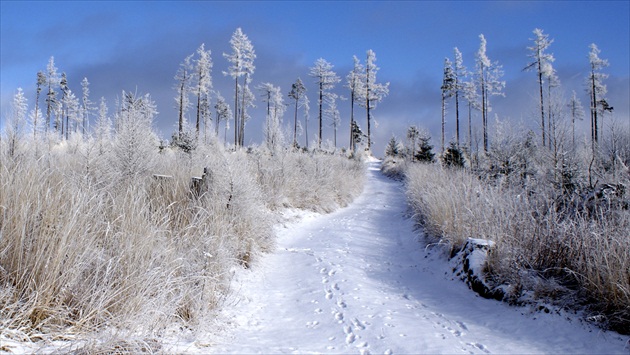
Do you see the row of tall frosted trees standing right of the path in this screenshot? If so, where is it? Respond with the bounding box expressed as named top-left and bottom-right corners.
top-left (440, 28), bottom-right (613, 160)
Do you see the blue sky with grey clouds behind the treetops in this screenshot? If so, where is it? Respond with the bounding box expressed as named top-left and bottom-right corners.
top-left (0, 1), bottom-right (630, 154)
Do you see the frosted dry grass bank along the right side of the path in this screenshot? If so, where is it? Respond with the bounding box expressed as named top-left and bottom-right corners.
top-left (407, 164), bottom-right (630, 332)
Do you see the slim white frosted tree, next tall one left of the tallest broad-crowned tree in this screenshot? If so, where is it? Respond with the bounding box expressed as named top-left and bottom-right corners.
top-left (195, 43), bottom-right (212, 137)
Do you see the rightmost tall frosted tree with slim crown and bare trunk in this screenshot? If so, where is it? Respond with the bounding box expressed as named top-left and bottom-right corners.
top-left (586, 43), bottom-right (608, 150)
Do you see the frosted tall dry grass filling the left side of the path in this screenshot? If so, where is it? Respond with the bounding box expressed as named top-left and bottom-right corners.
top-left (0, 138), bottom-right (362, 351)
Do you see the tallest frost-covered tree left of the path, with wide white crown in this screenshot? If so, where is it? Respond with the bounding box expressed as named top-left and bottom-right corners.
top-left (223, 27), bottom-right (256, 146)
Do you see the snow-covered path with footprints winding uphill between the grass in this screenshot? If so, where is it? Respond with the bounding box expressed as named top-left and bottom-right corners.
top-left (206, 163), bottom-right (630, 354)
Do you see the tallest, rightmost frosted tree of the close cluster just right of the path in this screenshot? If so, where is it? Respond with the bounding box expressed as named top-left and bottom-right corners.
top-left (476, 34), bottom-right (505, 152)
